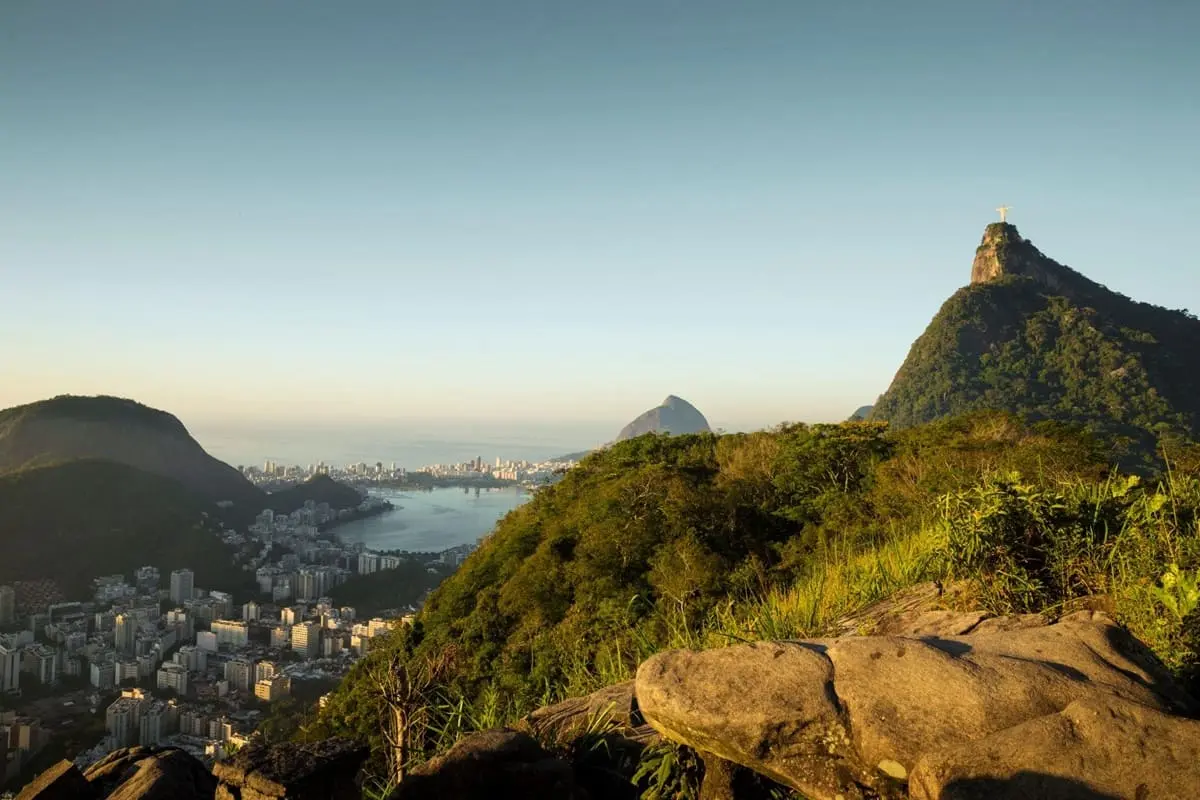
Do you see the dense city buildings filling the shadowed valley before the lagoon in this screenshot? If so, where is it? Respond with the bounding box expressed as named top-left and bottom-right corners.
top-left (0, 484), bottom-right (475, 788)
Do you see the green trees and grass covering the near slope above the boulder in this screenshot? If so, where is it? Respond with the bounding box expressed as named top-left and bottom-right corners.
top-left (306, 413), bottom-right (1200, 792)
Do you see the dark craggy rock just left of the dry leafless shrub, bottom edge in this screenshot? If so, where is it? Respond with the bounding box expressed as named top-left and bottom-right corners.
top-left (212, 739), bottom-right (368, 800)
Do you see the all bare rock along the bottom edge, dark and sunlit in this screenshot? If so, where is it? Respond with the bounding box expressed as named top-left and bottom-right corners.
top-left (20, 584), bottom-right (1200, 800)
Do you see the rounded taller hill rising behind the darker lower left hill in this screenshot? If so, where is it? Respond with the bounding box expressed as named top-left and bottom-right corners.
top-left (0, 396), bottom-right (264, 511)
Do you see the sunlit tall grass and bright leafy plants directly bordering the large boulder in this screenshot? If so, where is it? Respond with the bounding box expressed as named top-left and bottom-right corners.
top-left (357, 473), bottom-right (1200, 796)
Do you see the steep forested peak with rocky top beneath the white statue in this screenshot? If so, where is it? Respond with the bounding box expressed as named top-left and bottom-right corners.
top-left (871, 223), bottom-right (1200, 444)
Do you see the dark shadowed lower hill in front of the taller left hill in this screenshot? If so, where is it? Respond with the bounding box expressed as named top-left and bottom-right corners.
top-left (0, 461), bottom-right (246, 599)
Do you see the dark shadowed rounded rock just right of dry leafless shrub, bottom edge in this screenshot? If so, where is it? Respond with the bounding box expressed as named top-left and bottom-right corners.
top-left (388, 729), bottom-right (583, 800)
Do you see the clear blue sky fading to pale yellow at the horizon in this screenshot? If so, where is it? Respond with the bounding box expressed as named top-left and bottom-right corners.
top-left (0, 0), bottom-right (1200, 438)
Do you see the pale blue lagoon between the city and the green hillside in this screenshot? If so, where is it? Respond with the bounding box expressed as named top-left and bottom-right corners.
top-left (335, 488), bottom-right (532, 552)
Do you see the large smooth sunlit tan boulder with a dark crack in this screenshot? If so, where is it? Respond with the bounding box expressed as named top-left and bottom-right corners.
top-left (636, 612), bottom-right (1200, 800)
